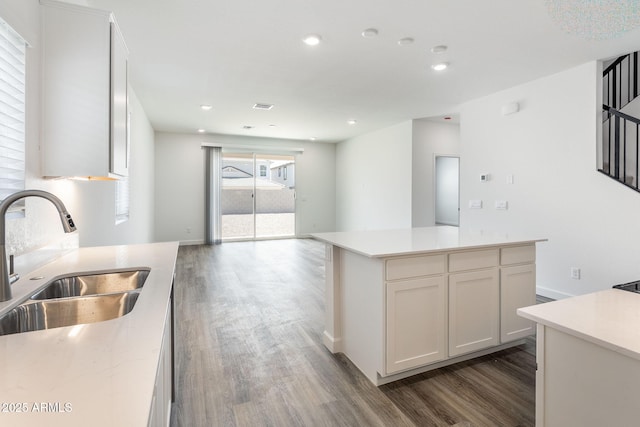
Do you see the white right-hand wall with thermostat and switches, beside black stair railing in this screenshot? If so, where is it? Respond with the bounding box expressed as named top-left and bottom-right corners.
top-left (460, 62), bottom-right (640, 298)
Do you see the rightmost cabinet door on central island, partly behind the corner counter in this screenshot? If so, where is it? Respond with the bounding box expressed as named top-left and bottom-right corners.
top-left (500, 264), bottom-right (536, 342)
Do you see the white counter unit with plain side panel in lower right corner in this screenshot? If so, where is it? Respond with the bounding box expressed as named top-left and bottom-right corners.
top-left (518, 289), bottom-right (640, 427)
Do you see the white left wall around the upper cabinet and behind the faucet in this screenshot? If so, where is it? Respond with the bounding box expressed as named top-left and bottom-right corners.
top-left (0, 0), bottom-right (153, 266)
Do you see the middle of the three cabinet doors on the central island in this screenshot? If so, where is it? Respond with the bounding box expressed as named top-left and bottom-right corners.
top-left (449, 268), bottom-right (500, 357)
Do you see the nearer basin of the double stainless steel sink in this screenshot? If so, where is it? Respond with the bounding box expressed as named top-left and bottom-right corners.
top-left (0, 290), bottom-right (140, 335)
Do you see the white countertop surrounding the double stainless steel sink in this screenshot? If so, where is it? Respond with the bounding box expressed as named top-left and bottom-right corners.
top-left (0, 242), bottom-right (178, 427)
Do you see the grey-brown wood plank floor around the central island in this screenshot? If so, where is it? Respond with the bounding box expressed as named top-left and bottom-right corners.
top-left (171, 239), bottom-right (535, 427)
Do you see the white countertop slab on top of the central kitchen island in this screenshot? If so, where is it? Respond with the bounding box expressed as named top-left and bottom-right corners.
top-left (311, 226), bottom-right (546, 258)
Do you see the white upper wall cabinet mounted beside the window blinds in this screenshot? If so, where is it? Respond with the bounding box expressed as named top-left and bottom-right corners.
top-left (40, 0), bottom-right (129, 179)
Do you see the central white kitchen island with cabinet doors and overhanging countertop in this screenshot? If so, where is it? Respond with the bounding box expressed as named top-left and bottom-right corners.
top-left (312, 226), bottom-right (545, 385)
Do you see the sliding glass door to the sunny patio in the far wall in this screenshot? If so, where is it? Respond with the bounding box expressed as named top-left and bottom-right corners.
top-left (221, 152), bottom-right (295, 241)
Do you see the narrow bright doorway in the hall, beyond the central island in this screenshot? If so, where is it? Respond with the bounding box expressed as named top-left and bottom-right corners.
top-left (435, 156), bottom-right (460, 227)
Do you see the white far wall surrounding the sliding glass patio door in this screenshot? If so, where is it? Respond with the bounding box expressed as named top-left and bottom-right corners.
top-left (155, 132), bottom-right (336, 244)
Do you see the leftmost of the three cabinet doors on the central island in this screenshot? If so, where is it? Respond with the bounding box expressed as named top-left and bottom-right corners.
top-left (386, 276), bottom-right (446, 374)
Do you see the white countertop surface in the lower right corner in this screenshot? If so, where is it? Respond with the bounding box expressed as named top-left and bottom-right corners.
top-left (517, 289), bottom-right (640, 360)
